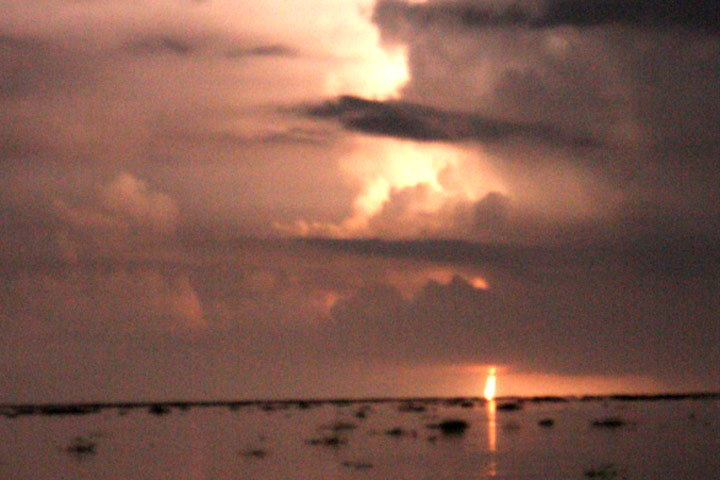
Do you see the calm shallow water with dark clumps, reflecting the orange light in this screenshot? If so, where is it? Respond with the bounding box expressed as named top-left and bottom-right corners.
top-left (0, 398), bottom-right (720, 480)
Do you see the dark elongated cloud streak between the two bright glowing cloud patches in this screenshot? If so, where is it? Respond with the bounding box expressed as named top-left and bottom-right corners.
top-left (305, 96), bottom-right (597, 147)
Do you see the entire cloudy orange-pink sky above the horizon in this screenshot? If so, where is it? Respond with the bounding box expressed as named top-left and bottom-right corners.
top-left (0, 0), bottom-right (720, 403)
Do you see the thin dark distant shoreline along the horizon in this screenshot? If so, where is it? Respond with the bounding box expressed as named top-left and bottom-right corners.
top-left (0, 392), bottom-right (720, 417)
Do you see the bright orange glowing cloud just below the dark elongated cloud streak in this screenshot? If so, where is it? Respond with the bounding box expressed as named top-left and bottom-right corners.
top-left (281, 137), bottom-right (507, 238)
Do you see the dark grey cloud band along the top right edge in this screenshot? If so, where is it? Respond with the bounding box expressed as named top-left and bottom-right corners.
top-left (375, 0), bottom-right (720, 34)
